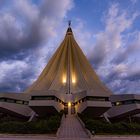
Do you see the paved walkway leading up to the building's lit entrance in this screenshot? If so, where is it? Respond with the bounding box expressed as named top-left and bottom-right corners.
top-left (58, 115), bottom-right (89, 140)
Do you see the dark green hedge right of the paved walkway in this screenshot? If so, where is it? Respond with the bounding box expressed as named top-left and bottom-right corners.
top-left (79, 114), bottom-right (140, 135)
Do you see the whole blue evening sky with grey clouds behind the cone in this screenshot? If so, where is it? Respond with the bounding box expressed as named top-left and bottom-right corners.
top-left (0, 0), bottom-right (140, 94)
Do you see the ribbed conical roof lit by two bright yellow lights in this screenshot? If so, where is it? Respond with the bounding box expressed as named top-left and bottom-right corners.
top-left (27, 26), bottom-right (112, 96)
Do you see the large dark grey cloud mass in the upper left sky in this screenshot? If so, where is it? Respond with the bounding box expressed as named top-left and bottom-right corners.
top-left (0, 0), bottom-right (72, 59)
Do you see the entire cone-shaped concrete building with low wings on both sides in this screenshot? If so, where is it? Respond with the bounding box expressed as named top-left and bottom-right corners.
top-left (0, 24), bottom-right (140, 120)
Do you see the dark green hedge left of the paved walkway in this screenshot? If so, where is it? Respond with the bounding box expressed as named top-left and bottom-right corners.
top-left (0, 115), bottom-right (61, 134)
